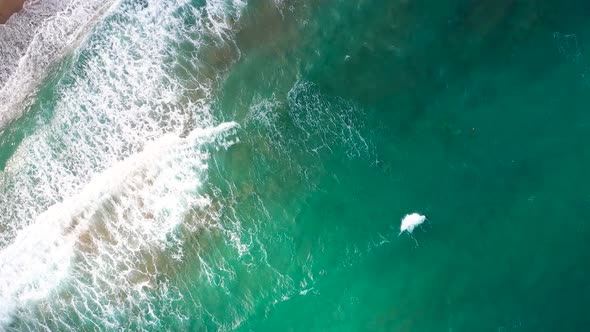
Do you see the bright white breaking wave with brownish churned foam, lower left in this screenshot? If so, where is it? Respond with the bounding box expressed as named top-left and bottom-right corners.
top-left (0, 123), bottom-right (236, 329)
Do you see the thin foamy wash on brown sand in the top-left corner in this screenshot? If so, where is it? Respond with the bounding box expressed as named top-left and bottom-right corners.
top-left (0, 0), bottom-right (119, 128)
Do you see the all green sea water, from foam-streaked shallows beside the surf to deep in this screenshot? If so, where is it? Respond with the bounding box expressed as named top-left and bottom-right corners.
top-left (0, 0), bottom-right (590, 331)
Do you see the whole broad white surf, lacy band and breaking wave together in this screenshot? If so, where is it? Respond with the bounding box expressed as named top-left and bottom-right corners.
top-left (0, 0), bottom-right (245, 331)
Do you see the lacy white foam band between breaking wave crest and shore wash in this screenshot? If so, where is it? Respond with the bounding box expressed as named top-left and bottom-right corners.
top-left (0, 1), bottom-right (243, 248)
